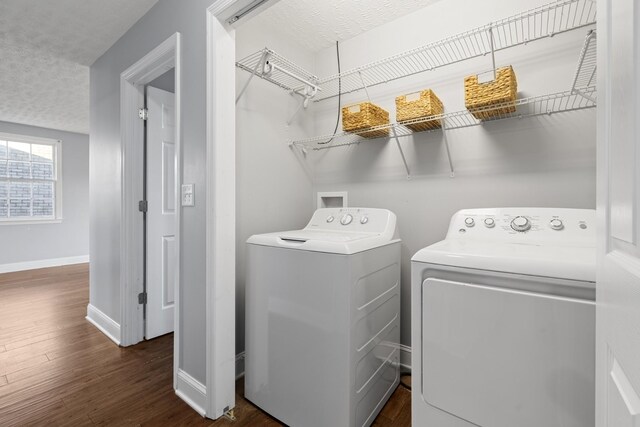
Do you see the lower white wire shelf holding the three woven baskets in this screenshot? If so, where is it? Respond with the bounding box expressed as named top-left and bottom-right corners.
top-left (290, 87), bottom-right (596, 150)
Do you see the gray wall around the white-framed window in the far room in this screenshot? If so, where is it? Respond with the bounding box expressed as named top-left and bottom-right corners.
top-left (0, 122), bottom-right (89, 265)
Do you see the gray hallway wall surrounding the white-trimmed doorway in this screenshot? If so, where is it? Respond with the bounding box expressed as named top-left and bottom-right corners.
top-left (90, 0), bottom-right (213, 384)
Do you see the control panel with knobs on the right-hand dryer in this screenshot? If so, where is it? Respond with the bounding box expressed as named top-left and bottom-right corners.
top-left (447, 208), bottom-right (595, 246)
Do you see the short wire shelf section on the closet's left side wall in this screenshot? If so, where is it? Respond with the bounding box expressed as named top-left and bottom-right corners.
top-left (236, 48), bottom-right (319, 95)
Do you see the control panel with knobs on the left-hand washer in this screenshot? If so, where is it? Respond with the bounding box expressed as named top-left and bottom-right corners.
top-left (305, 208), bottom-right (396, 235)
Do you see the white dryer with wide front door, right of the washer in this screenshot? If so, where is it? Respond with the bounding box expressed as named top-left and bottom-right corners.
top-left (411, 208), bottom-right (596, 427)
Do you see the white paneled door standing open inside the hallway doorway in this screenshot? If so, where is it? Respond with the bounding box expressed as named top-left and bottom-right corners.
top-left (145, 87), bottom-right (177, 339)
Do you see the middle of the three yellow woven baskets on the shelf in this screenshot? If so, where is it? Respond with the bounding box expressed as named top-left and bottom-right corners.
top-left (396, 89), bottom-right (444, 132)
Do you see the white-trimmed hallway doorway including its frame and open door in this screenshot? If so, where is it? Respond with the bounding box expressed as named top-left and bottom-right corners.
top-left (120, 33), bottom-right (181, 388)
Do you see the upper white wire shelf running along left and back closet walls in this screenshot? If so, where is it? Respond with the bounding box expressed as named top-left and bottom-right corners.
top-left (236, 0), bottom-right (596, 101)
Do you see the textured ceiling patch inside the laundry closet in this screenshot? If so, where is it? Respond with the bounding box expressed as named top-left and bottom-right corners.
top-left (254, 0), bottom-right (439, 52)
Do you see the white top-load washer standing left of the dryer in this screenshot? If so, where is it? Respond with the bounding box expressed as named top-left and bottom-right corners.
top-left (245, 208), bottom-right (400, 427)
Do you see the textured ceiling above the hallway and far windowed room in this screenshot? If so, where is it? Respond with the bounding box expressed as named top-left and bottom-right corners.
top-left (0, 0), bottom-right (157, 133)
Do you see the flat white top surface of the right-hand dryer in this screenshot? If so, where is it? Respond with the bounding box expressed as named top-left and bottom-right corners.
top-left (411, 239), bottom-right (596, 282)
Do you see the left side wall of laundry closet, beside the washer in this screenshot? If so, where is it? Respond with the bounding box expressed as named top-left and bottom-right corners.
top-left (236, 21), bottom-right (314, 353)
